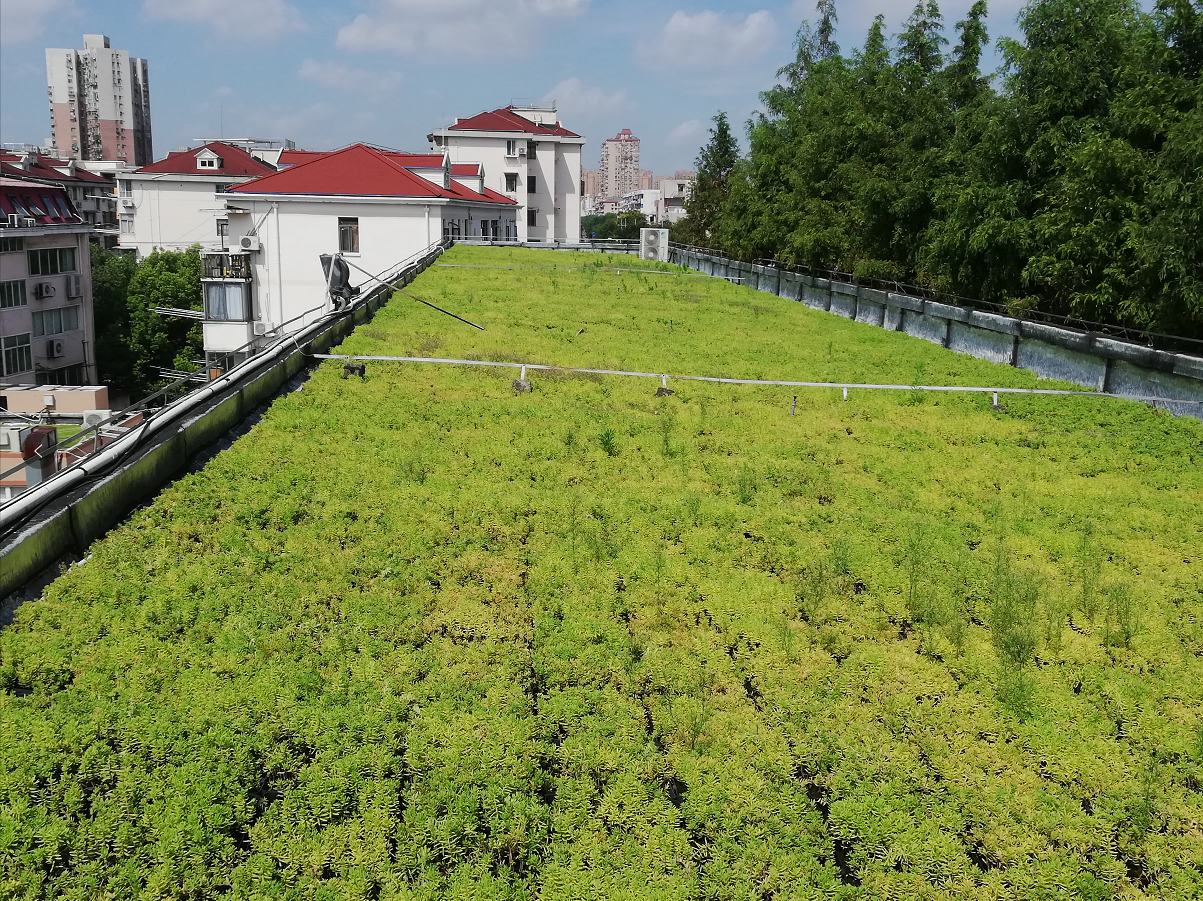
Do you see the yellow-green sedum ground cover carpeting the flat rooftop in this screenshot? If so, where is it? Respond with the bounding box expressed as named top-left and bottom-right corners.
top-left (7, 242), bottom-right (1203, 899)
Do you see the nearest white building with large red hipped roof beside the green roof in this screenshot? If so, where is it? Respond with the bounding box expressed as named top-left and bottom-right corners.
top-left (203, 144), bottom-right (517, 368)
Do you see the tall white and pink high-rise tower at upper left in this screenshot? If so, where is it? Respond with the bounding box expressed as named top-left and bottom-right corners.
top-left (46, 35), bottom-right (154, 166)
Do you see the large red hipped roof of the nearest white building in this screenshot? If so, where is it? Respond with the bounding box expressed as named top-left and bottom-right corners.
top-left (229, 144), bottom-right (514, 204)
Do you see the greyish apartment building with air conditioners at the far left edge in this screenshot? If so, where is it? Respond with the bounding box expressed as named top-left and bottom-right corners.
top-left (0, 176), bottom-right (96, 385)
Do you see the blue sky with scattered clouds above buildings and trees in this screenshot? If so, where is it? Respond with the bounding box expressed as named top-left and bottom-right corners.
top-left (0, 0), bottom-right (1021, 174)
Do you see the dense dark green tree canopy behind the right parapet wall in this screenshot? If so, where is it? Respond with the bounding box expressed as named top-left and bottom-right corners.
top-left (678, 0), bottom-right (1203, 336)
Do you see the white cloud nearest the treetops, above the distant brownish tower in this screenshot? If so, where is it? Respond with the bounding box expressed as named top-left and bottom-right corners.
top-left (640, 10), bottom-right (777, 72)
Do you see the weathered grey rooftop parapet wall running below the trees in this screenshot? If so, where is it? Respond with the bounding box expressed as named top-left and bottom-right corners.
top-left (670, 247), bottom-right (1203, 419)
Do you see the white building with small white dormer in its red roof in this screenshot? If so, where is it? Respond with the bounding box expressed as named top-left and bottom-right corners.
top-left (117, 141), bottom-right (275, 257)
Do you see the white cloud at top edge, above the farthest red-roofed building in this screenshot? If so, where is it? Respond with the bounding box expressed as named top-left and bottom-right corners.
top-left (337, 0), bottom-right (589, 58)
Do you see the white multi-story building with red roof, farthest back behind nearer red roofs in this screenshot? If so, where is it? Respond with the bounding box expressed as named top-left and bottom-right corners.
top-left (427, 106), bottom-right (585, 243)
